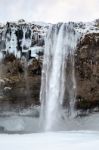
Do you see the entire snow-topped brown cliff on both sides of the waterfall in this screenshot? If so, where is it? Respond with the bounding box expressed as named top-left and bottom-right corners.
top-left (0, 20), bottom-right (99, 111)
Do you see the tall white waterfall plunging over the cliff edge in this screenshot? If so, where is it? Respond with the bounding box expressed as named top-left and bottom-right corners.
top-left (40, 23), bottom-right (79, 131)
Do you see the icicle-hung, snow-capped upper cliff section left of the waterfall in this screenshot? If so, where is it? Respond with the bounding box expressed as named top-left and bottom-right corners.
top-left (0, 20), bottom-right (49, 59)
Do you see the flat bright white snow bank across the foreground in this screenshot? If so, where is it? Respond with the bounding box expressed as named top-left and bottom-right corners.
top-left (0, 131), bottom-right (99, 150)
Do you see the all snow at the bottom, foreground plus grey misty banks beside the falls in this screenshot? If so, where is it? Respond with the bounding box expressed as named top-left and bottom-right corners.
top-left (0, 108), bottom-right (99, 150)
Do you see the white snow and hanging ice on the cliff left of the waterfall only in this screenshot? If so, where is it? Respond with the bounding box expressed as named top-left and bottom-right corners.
top-left (0, 19), bottom-right (48, 58)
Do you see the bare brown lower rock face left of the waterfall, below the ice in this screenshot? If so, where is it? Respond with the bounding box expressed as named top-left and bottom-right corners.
top-left (0, 54), bottom-right (42, 111)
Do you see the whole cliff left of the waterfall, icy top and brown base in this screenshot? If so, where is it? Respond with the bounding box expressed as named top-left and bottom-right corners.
top-left (0, 20), bottom-right (49, 111)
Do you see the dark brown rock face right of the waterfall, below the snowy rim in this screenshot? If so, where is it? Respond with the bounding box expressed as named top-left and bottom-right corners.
top-left (75, 33), bottom-right (99, 110)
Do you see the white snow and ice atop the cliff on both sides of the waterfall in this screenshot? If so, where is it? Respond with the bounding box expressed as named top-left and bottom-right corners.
top-left (0, 19), bottom-right (99, 58)
